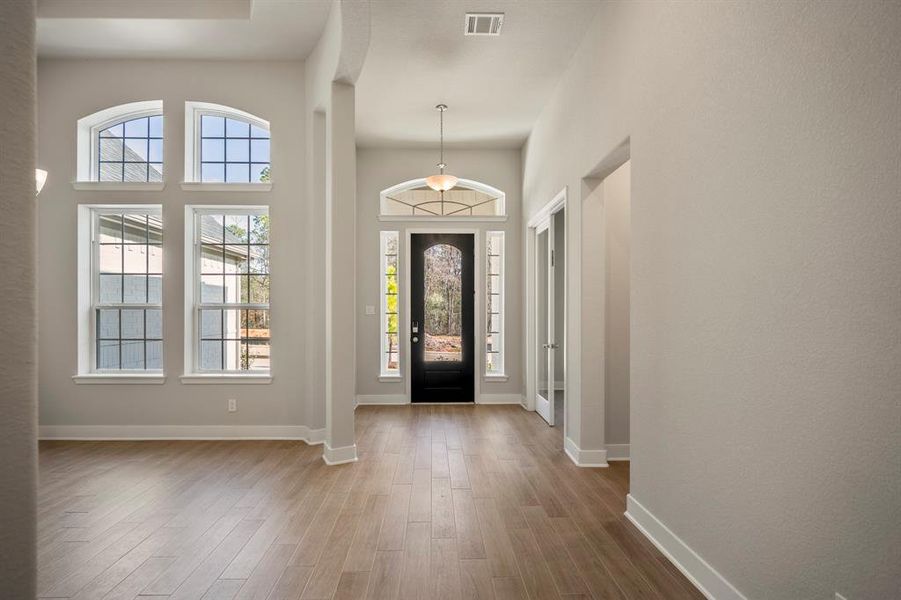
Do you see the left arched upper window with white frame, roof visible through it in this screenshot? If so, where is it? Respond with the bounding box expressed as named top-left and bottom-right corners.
top-left (77, 100), bottom-right (163, 184)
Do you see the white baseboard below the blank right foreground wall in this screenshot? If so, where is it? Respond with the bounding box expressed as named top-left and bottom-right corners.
top-left (626, 494), bottom-right (747, 600)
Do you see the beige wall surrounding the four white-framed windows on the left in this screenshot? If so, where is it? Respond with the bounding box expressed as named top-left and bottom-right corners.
top-left (38, 60), bottom-right (312, 429)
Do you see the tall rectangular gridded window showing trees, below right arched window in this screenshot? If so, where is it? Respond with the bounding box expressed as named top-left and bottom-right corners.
top-left (192, 207), bottom-right (270, 373)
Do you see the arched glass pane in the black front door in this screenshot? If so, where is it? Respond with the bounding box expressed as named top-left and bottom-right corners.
top-left (423, 244), bottom-right (463, 362)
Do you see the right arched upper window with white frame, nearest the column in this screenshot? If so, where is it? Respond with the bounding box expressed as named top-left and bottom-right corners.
top-left (185, 102), bottom-right (271, 184)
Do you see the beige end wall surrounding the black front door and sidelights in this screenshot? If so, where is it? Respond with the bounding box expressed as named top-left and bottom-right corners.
top-left (356, 148), bottom-right (522, 396)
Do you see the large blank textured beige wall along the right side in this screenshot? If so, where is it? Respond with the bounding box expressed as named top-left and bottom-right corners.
top-left (523, 2), bottom-right (901, 600)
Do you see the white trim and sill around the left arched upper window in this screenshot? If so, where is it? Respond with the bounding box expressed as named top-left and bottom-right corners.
top-left (73, 100), bottom-right (167, 184)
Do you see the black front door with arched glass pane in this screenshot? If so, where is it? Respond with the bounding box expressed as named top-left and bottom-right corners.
top-left (410, 233), bottom-right (475, 402)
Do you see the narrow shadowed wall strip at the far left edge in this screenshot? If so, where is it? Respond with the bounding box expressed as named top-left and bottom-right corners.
top-left (0, 0), bottom-right (38, 599)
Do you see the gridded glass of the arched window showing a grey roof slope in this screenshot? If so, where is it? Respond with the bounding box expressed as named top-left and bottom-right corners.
top-left (96, 115), bottom-right (163, 182)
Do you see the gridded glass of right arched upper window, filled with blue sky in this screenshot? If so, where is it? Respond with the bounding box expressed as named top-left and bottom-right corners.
top-left (200, 114), bottom-right (271, 183)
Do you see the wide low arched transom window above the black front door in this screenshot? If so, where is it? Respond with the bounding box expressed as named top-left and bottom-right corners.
top-left (379, 179), bottom-right (507, 221)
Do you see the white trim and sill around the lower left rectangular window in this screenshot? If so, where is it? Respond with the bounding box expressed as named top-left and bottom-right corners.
top-left (72, 204), bottom-right (166, 383)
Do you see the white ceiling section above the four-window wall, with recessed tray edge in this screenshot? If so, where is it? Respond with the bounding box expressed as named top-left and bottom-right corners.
top-left (37, 0), bottom-right (331, 60)
